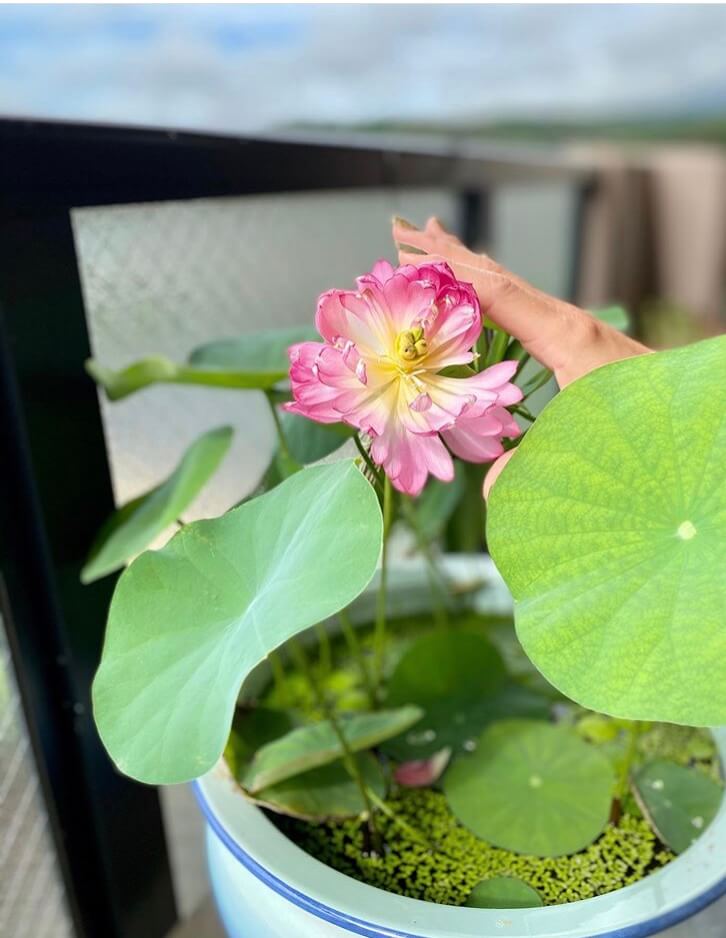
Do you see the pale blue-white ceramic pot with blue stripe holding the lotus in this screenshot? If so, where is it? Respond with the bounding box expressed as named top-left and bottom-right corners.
top-left (194, 561), bottom-right (726, 938)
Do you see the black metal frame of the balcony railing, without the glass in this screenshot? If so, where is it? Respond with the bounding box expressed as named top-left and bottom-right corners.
top-left (0, 121), bottom-right (589, 938)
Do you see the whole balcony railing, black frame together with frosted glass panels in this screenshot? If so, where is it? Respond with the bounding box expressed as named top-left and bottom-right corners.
top-left (0, 121), bottom-right (594, 938)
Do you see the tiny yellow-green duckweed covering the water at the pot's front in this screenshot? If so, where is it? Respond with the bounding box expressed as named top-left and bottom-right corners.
top-left (278, 788), bottom-right (673, 905)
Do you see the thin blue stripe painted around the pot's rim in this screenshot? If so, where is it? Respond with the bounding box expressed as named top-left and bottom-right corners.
top-left (192, 781), bottom-right (726, 938)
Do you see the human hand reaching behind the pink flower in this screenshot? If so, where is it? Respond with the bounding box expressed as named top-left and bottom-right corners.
top-left (393, 218), bottom-right (651, 497)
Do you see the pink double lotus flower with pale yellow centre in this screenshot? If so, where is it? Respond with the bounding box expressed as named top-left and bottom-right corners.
top-left (285, 261), bottom-right (522, 495)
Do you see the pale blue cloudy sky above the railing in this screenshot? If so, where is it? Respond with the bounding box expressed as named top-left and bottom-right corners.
top-left (0, 4), bottom-right (726, 132)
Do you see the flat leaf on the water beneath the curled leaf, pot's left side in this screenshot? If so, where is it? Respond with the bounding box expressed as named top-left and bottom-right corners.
top-left (254, 752), bottom-right (386, 821)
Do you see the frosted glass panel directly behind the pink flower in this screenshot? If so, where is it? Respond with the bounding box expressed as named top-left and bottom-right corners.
top-left (73, 190), bottom-right (457, 517)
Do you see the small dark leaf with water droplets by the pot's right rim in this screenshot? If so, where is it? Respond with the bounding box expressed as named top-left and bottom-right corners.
top-left (634, 759), bottom-right (723, 853)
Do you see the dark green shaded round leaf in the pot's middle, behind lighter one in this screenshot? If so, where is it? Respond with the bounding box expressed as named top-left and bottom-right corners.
top-left (383, 631), bottom-right (506, 762)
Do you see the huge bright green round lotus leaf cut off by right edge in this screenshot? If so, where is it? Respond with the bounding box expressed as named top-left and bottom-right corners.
top-left (487, 337), bottom-right (726, 726)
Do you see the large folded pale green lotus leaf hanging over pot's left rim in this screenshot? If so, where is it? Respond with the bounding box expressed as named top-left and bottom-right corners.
top-left (93, 460), bottom-right (382, 784)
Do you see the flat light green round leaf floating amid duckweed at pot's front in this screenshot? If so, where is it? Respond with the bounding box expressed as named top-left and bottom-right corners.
top-left (444, 720), bottom-right (614, 857)
